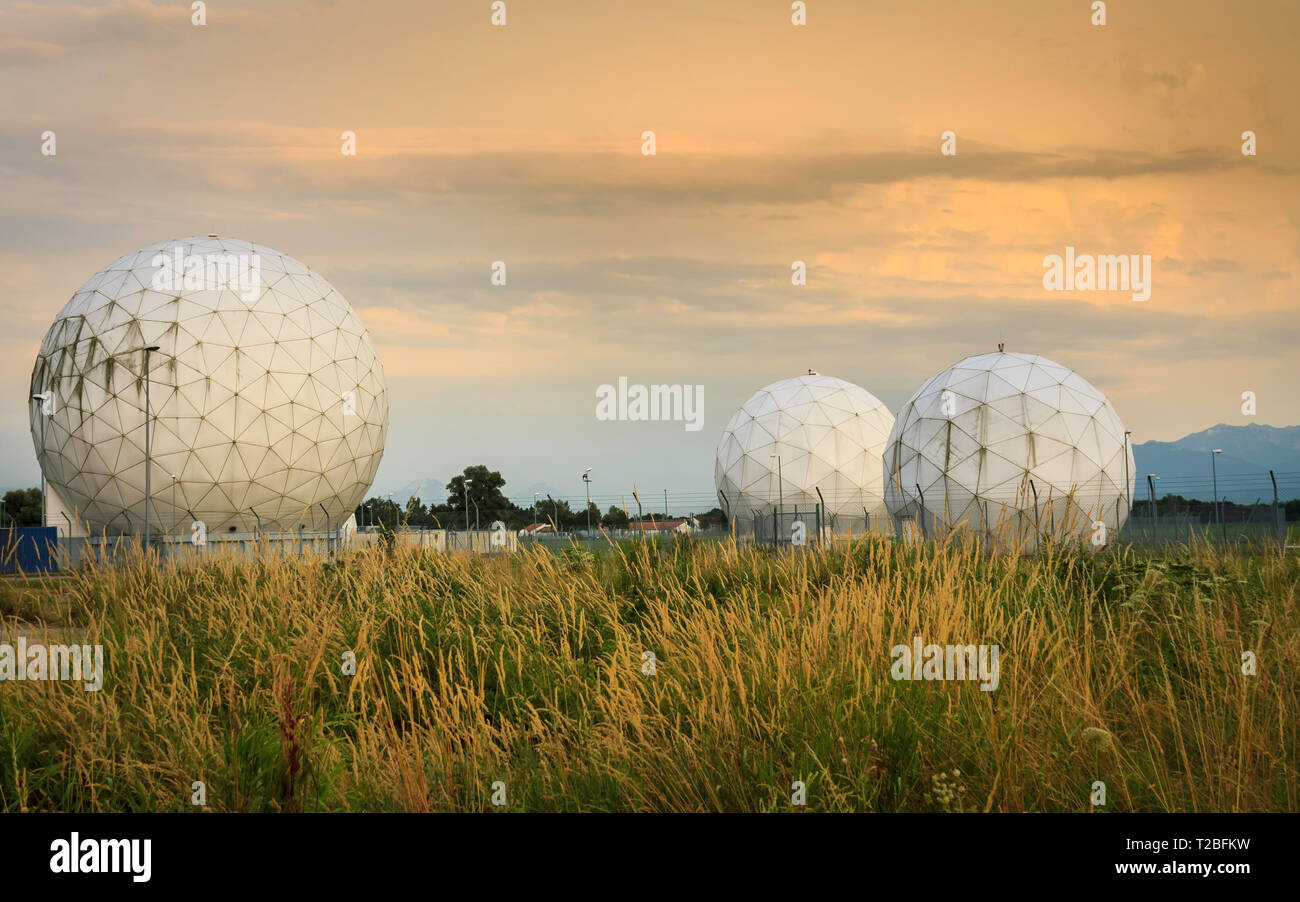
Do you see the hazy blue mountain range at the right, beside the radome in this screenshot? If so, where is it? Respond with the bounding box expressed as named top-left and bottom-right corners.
top-left (1134, 422), bottom-right (1300, 503)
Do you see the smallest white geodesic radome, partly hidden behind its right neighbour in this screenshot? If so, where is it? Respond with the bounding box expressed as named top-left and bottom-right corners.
top-left (714, 373), bottom-right (893, 533)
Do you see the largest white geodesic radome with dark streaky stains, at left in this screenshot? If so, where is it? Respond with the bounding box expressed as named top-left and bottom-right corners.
top-left (30, 238), bottom-right (389, 535)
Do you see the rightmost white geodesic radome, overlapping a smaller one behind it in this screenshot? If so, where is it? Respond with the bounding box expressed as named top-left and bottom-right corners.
top-left (884, 351), bottom-right (1136, 541)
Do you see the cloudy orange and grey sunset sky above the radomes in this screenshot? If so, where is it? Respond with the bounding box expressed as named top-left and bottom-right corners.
top-left (0, 0), bottom-right (1300, 512)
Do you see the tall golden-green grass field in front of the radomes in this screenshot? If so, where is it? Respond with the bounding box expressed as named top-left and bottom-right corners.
top-left (0, 538), bottom-right (1300, 811)
